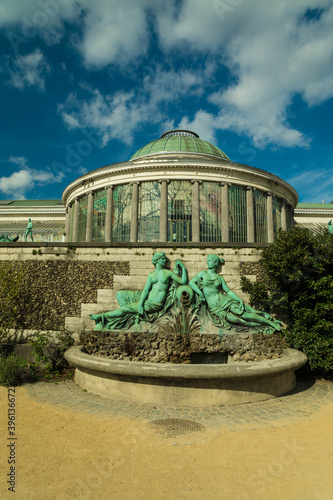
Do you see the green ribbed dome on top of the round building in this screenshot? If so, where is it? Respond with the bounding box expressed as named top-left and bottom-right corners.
top-left (130, 130), bottom-right (229, 160)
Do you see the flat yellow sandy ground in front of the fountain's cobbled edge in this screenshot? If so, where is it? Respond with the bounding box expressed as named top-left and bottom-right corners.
top-left (0, 387), bottom-right (333, 500)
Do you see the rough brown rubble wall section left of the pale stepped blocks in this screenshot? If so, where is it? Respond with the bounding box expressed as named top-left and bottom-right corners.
top-left (0, 260), bottom-right (130, 330)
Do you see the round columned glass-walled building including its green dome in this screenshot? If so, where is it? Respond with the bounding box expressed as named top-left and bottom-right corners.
top-left (62, 130), bottom-right (298, 244)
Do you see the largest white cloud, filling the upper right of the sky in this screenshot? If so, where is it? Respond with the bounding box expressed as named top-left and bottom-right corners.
top-left (157, 0), bottom-right (333, 148)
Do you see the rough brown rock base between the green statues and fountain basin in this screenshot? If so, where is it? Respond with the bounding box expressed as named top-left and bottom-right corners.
top-left (81, 330), bottom-right (289, 364)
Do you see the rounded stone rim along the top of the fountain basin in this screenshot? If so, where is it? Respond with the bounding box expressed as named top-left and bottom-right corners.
top-left (65, 345), bottom-right (307, 379)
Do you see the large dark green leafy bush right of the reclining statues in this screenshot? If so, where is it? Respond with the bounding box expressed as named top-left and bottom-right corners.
top-left (242, 226), bottom-right (333, 373)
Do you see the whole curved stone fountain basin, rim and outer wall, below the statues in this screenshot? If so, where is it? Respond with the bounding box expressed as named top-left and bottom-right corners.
top-left (65, 346), bottom-right (307, 407)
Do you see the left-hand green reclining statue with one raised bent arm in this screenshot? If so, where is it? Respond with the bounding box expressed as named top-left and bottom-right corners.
top-left (89, 252), bottom-right (188, 330)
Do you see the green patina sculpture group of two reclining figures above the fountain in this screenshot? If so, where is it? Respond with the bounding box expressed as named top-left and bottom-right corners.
top-left (89, 252), bottom-right (282, 333)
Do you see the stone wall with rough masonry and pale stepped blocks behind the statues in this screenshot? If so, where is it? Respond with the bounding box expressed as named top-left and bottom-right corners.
top-left (0, 243), bottom-right (261, 332)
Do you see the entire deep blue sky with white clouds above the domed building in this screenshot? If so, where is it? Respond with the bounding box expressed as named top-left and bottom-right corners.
top-left (0, 0), bottom-right (333, 203)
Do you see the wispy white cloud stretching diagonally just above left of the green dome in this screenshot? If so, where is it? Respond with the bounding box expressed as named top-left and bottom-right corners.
top-left (59, 68), bottom-right (204, 146)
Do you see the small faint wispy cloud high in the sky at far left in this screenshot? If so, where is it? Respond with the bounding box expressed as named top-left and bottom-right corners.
top-left (9, 49), bottom-right (50, 91)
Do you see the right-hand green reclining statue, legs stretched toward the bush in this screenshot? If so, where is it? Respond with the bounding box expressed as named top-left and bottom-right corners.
top-left (189, 254), bottom-right (282, 333)
